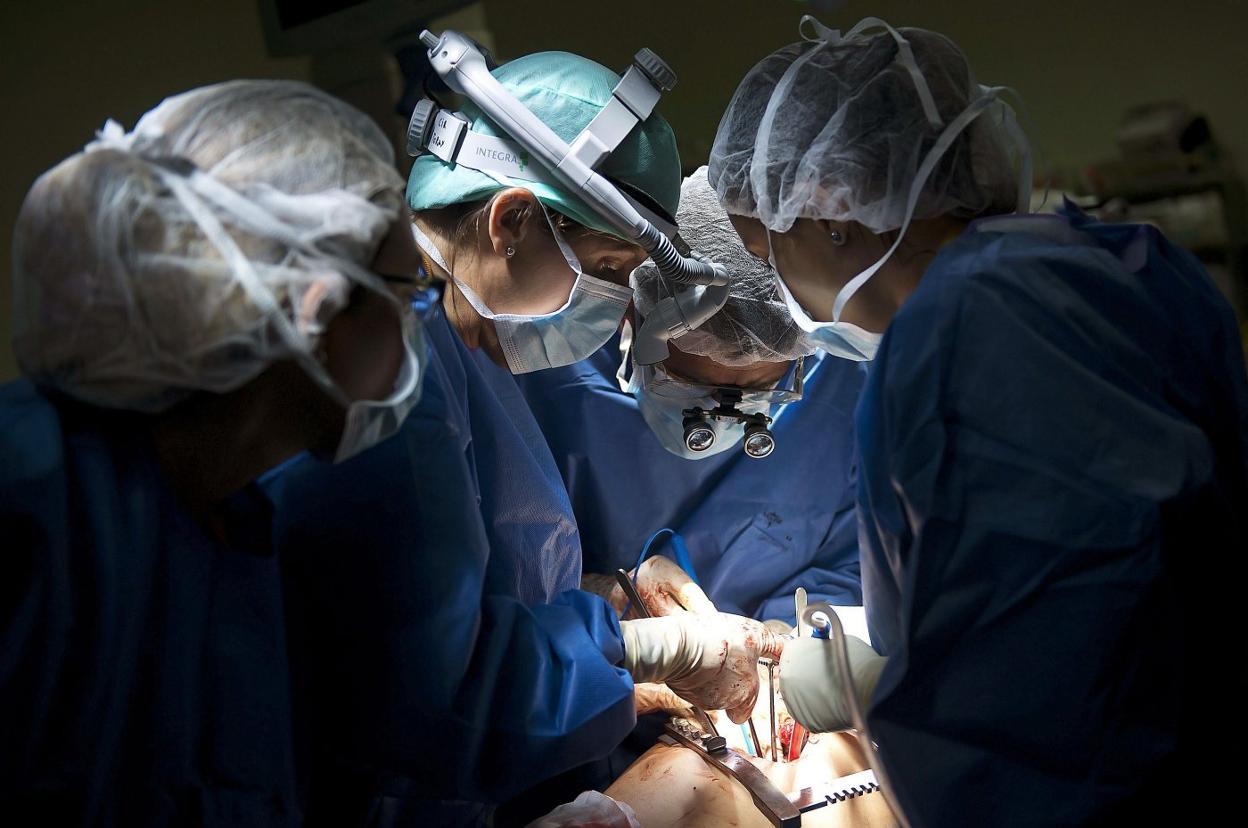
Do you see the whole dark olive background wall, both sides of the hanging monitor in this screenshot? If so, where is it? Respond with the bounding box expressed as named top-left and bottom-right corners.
top-left (0, 0), bottom-right (1248, 382)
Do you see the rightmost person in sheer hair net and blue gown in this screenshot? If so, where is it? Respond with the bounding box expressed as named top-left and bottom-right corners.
top-left (710, 19), bottom-right (1248, 826)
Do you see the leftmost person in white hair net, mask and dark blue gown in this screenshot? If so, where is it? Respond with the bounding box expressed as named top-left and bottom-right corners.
top-left (0, 81), bottom-right (422, 827)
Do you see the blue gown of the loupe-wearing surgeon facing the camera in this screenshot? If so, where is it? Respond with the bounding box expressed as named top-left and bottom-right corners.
top-left (519, 340), bottom-right (864, 623)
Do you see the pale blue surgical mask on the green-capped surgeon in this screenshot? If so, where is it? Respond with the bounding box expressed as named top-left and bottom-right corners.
top-left (412, 209), bottom-right (633, 373)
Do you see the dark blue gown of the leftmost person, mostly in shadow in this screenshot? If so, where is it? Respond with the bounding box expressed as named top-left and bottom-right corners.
top-left (0, 382), bottom-right (301, 828)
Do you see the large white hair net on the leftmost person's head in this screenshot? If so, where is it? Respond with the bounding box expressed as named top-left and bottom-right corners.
top-left (14, 81), bottom-right (403, 412)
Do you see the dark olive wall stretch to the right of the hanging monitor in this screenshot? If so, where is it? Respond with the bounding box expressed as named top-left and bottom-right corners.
top-left (485, 0), bottom-right (1248, 181)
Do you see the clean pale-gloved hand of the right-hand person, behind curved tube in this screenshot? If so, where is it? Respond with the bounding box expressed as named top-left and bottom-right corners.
top-left (780, 636), bottom-right (889, 733)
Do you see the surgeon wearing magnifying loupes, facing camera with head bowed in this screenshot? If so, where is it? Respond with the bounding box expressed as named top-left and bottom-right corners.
top-left (520, 167), bottom-right (864, 624)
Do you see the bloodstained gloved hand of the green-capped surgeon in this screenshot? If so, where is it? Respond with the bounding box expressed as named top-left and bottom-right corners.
top-left (620, 611), bottom-right (785, 724)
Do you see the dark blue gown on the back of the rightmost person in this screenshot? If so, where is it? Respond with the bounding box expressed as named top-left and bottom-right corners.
top-left (857, 207), bottom-right (1248, 826)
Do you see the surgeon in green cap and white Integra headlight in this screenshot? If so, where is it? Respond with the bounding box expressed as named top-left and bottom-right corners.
top-left (270, 46), bottom-right (781, 826)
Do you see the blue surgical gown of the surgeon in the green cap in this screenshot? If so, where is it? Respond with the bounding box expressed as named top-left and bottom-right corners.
top-left (271, 303), bottom-right (635, 824)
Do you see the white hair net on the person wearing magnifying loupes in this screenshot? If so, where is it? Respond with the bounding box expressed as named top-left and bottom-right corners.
top-left (631, 167), bottom-right (815, 367)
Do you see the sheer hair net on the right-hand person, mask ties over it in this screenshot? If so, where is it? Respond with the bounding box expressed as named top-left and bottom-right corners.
top-left (710, 16), bottom-right (1030, 234)
